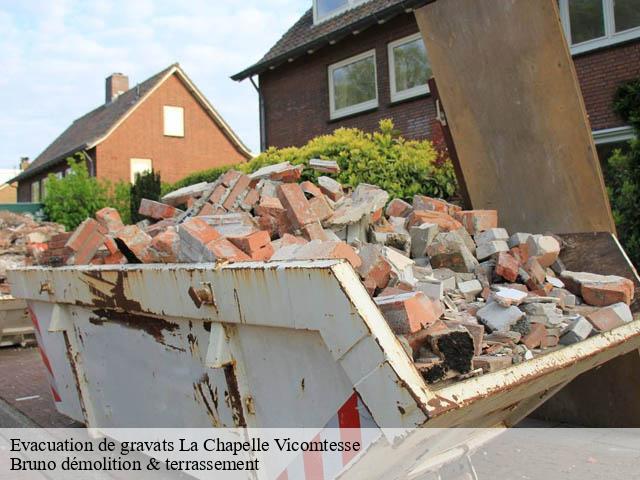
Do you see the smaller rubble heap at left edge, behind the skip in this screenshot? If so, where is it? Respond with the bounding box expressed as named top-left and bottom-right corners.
top-left (0, 210), bottom-right (64, 295)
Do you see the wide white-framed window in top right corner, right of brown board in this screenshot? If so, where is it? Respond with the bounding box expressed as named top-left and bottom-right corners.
top-left (560, 0), bottom-right (640, 53)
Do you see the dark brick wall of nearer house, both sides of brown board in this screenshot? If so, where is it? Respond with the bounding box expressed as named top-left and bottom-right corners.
top-left (260, 14), bottom-right (640, 147)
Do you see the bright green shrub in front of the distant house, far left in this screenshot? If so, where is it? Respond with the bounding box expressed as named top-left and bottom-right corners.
top-left (43, 153), bottom-right (130, 230)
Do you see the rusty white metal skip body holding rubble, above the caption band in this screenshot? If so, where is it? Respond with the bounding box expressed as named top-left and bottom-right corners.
top-left (9, 260), bottom-right (640, 434)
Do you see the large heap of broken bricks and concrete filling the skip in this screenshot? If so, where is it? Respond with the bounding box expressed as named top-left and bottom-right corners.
top-left (35, 161), bottom-right (634, 383)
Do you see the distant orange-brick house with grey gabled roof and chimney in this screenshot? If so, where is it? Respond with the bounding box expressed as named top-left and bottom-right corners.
top-left (14, 64), bottom-right (251, 202)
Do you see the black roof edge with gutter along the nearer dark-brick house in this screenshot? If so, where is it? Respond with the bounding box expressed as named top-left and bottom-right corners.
top-left (231, 0), bottom-right (436, 82)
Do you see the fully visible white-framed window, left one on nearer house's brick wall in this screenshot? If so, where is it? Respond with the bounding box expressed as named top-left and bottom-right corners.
top-left (329, 50), bottom-right (378, 119)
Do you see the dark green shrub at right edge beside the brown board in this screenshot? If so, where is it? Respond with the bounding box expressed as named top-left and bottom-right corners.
top-left (603, 79), bottom-right (640, 265)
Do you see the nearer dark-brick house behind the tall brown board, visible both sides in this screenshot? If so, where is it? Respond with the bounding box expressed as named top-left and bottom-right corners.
top-left (232, 0), bottom-right (640, 158)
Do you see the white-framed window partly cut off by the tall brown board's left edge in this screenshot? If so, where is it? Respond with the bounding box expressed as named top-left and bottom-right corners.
top-left (389, 33), bottom-right (431, 102)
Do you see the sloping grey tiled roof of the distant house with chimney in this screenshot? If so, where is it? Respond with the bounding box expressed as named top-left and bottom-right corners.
top-left (13, 64), bottom-right (177, 181)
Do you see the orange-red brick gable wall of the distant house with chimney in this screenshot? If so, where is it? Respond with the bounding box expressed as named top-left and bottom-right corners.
top-left (96, 75), bottom-right (246, 186)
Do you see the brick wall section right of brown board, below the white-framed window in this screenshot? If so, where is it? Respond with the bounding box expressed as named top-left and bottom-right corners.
top-left (573, 40), bottom-right (640, 130)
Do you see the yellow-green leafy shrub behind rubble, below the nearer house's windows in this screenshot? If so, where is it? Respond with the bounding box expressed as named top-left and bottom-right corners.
top-left (165, 120), bottom-right (456, 200)
